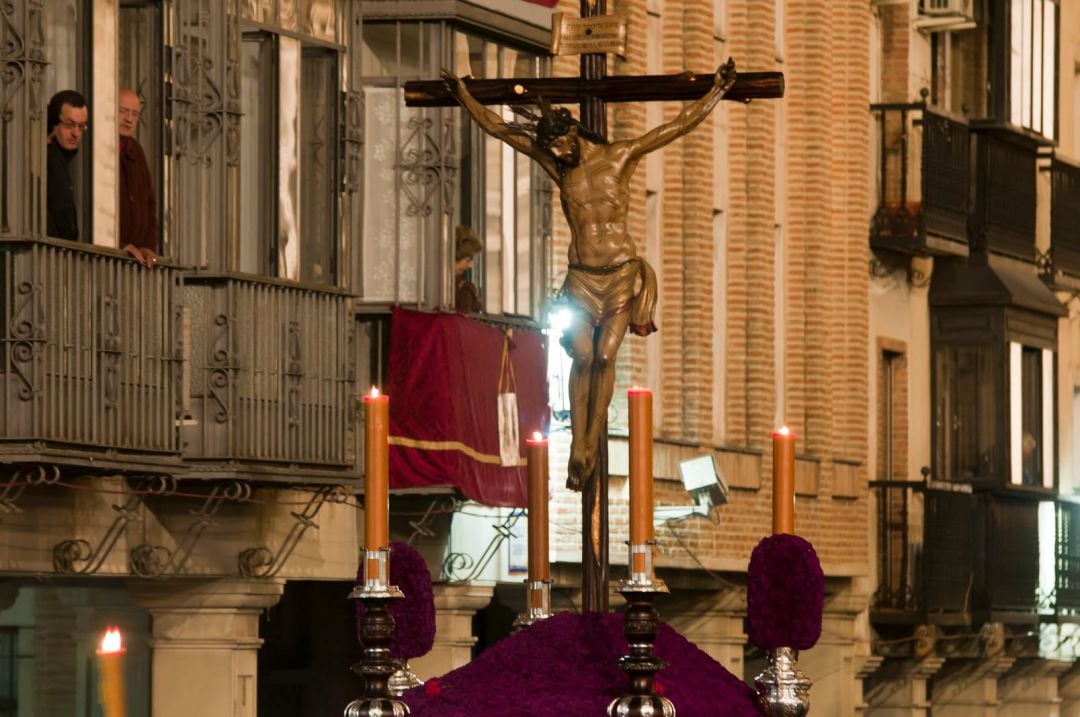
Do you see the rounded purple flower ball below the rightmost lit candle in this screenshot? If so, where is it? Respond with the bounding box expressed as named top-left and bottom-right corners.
top-left (746, 533), bottom-right (825, 650)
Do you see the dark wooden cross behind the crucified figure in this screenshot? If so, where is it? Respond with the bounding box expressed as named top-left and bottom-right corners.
top-left (405, 0), bottom-right (784, 612)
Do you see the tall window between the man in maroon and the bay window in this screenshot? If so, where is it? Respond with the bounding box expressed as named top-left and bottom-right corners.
top-left (234, 18), bottom-right (340, 285)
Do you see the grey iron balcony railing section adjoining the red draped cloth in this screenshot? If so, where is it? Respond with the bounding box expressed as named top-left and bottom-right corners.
top-left (180, 273), bottom-right (357, 481)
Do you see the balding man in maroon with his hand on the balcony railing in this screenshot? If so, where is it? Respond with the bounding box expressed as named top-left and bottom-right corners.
top-left (119, 87), bottom-right (158, 267)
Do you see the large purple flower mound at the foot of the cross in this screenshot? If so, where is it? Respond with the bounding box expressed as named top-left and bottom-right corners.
top-left (404, 612), bottom-right (759, 717)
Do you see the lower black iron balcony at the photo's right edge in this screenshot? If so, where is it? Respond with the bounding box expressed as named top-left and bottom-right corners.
top-left (870, 481), bottom-right (1080, 625)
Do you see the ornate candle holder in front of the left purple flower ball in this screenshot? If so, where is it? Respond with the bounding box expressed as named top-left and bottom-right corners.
top-left (345, 547), bottom-right (409, 717)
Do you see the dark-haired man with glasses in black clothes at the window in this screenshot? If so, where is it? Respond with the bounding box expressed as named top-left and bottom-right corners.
top-left (46, 90), bottom-right (90, 241)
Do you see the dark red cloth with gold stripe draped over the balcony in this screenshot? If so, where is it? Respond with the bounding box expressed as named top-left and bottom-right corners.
top-left (387, 308), bottom-right (551, 508)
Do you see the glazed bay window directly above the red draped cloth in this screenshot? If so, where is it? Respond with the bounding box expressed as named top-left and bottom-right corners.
top-left (361, 22), bottom-right (551, 315)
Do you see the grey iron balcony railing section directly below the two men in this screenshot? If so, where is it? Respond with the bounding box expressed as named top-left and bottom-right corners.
top-left (0, 240), bottom-right (180, 473)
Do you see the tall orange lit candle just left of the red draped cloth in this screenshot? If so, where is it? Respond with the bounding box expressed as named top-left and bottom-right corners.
top-left (364, 387), bottom-right (390, 577)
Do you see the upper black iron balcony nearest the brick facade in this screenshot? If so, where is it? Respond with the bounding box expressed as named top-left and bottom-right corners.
top-left (870, 104), bottom-right (970, 255)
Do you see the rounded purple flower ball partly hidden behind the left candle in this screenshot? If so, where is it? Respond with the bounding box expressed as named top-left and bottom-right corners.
top-left (356, 542), bottom-right (435, 660)
